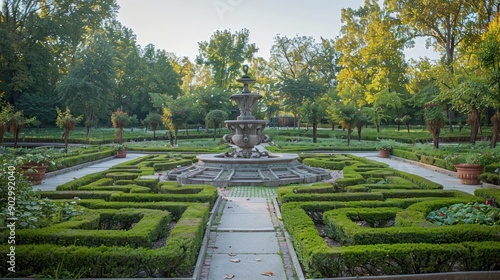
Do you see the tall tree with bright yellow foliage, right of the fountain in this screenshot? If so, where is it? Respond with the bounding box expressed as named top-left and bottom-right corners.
top-left (335, 0), bottom-right (412, 106)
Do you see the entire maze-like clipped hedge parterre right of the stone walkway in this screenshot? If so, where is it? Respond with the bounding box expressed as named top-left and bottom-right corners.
top-left (278, 154), bottom-right (500, 278)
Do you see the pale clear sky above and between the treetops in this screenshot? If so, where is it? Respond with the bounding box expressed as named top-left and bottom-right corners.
top-left (117, 0), bottom-right (439, 60)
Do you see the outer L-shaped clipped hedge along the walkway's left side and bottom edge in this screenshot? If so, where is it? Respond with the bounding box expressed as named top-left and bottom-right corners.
top-left (0, 203), bottom-right (210, 278)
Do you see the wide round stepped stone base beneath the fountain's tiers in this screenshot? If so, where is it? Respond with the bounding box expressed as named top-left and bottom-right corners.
top-left (167, 150), bottom-right (331, 187)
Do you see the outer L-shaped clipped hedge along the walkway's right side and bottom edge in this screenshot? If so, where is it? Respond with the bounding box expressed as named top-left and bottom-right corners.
top-left (281, 202), bottom-right (500, 278)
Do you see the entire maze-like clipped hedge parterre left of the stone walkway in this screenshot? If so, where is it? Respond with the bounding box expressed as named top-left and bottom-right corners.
top-left (0, 155), bottom-right (217, 278)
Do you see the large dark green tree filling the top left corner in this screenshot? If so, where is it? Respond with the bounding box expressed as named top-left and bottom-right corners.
top-left (0, 0), bottom-right (117, 110)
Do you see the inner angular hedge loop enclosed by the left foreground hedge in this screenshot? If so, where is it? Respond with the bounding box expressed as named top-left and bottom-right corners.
top-left (12, 208), bottom-right (171, 248)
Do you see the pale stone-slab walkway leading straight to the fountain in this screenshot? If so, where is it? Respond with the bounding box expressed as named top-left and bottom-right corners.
top-left (201, 187), bottom-right (295, 279)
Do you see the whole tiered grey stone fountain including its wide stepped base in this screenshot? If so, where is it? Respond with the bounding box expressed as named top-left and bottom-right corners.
top-left (167, 66), bottom-right (331, 187)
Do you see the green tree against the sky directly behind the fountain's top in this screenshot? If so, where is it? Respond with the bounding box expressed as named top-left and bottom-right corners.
top-left (196, 29), bottom-right (258, 89)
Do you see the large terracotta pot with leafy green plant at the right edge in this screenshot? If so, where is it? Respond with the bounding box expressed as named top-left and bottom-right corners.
top-left (445, 152), bottom-right (500, 185)
